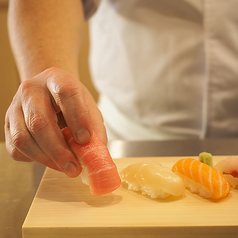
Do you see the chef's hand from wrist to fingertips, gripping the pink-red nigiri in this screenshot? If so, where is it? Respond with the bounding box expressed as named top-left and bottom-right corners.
top-left (5, 68), bottom-right (107, 177)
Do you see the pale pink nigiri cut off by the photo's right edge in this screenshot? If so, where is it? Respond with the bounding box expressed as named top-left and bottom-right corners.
top-left (214, 156), bottom-right (238, 188)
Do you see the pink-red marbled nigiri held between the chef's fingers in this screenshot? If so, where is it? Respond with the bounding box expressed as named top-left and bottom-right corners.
top-left (62, 127), bottom-right (121, 195)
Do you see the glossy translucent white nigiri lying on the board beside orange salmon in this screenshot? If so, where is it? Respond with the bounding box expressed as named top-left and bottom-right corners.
top-left (120, 163), bottom-right (185, 198)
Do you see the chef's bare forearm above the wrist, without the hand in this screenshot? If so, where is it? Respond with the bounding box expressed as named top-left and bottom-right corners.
top-left (8, 0), bottom-right (84, 81)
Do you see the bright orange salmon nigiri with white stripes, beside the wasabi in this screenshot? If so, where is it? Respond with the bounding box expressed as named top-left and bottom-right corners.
top-left (172, 158), bottom-right (231, 199)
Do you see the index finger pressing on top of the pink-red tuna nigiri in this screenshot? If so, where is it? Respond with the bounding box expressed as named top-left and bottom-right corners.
top-left (46, 69), bottom-right (93, 144)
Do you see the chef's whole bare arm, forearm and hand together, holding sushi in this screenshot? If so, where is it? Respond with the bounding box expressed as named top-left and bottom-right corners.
top-left (5, 0), bottom-right (107, 177)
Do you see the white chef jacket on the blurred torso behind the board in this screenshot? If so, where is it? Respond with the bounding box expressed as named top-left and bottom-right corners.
top-left (84, 0), bottom-right (238, 140)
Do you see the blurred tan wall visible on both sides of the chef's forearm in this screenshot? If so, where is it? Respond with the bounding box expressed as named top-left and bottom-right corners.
top-left (0, 0), bottom-right (98, 141)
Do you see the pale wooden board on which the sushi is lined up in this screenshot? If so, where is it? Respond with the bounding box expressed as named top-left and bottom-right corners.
top-left (23, 156), bottom-right (238, 238)
